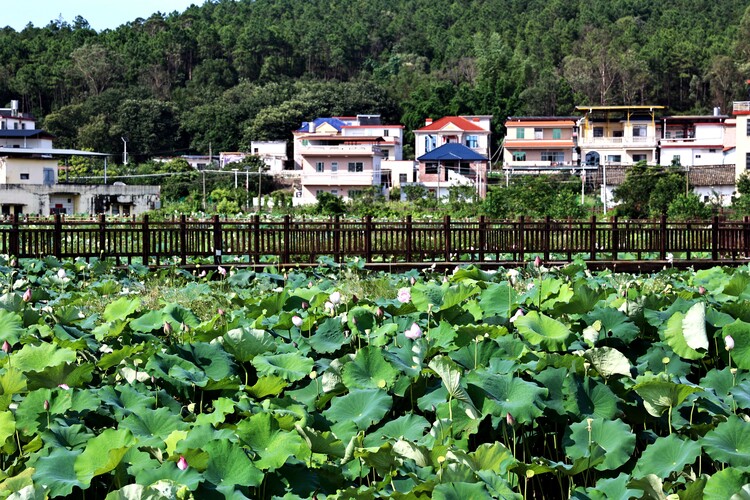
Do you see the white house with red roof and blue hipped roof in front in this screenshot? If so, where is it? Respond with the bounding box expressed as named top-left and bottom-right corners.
top-left (414, 115), bottom-right (492, 198)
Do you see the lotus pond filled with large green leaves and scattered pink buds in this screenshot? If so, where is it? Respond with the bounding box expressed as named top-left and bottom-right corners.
top-left (0, 257), bottom-right (750, 500)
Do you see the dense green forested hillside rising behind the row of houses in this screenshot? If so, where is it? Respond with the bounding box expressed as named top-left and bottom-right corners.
top-left (0, 0), bottom-right (750, 158)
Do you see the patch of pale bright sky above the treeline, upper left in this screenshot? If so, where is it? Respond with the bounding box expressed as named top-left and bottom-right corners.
top-left (0, 0), bottom-right (203, 31)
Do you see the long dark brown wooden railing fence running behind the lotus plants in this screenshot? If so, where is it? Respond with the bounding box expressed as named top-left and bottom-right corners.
top-left (0, 215), bottom-right (750, 265)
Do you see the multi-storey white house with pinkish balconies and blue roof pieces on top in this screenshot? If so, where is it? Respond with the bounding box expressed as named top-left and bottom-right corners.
top-left (293, 115), bottom-right (403, 204)
